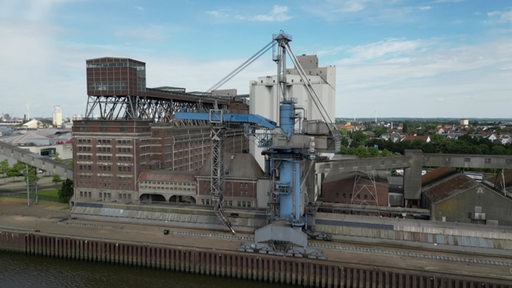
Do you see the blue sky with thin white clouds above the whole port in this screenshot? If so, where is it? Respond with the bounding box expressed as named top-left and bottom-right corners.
top-left (0, 0), bottom-right (512, 118)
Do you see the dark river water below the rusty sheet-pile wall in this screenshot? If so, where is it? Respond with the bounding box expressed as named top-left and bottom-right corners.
top-left (0, 251), bottom-right (291, 288)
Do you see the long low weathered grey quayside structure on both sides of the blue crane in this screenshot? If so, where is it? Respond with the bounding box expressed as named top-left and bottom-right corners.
top-left (71, 203), bottom-right (512, 253)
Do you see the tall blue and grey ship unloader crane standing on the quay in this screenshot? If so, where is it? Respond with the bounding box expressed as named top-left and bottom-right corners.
top-left (175, 33), bottom-right (339, 258)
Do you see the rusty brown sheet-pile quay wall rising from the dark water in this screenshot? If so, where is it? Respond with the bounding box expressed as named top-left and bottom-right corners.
top-left (0, 230), bottom-right (510, 288)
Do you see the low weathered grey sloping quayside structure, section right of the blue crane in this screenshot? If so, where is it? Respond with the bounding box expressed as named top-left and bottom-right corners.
top-left (315, 213), bottom-right (512, 253)
